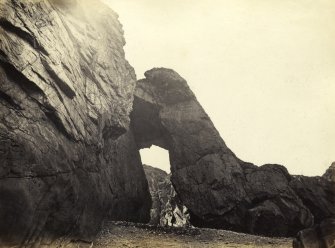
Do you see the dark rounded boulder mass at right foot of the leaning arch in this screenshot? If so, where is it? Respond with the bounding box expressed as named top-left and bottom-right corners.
top-left (241, 163), bottom-right (314, 236)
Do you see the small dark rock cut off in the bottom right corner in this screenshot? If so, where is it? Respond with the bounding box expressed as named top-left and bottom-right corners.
top-left (293, 219), bottom-right (335, 248)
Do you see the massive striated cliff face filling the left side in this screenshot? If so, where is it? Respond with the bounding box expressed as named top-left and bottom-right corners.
top-left (0, 0), bottom-right (151, 244)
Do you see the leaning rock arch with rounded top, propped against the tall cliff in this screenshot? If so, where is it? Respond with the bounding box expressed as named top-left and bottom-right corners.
top-left (131, 69), bottom-right (246, 229)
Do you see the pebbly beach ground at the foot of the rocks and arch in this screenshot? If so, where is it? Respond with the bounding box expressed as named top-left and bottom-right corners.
top-left (88, 222), bottom-right (292, 248)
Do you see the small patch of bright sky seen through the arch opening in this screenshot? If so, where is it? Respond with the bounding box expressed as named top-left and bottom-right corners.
top-left (140, 145), bottom-right (171, 173)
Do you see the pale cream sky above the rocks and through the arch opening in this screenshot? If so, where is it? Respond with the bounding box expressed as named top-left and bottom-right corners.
top-left (106, 0), bottom-right (335, 175)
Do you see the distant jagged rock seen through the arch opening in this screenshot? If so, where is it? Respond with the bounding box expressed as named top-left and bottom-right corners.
top-left (143, 165), bottom-right (190, 227)
